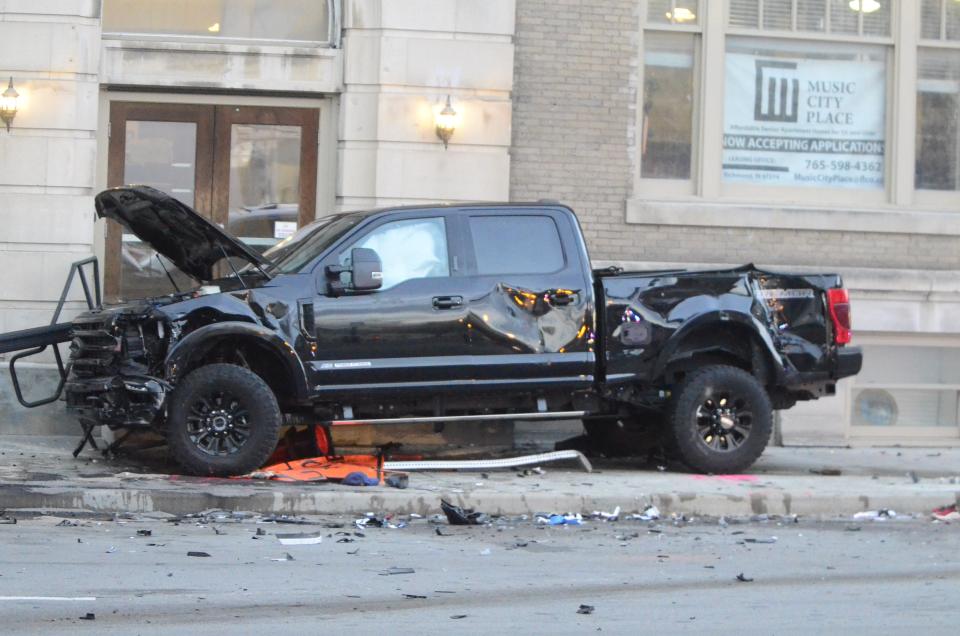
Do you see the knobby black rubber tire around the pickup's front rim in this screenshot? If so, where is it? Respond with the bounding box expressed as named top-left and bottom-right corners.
top-left (167, 364), bottom-right (283, 477)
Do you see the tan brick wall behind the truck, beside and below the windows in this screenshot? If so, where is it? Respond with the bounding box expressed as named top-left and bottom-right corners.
top-left (510, 0), bottom-right (960, 269)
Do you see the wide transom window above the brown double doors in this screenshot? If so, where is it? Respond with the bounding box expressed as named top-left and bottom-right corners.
top-left (103, 0), bottom-right (330, 43)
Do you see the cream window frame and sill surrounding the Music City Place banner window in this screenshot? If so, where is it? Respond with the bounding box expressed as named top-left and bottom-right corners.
top-left (626, 0), bottom-right (960, 236)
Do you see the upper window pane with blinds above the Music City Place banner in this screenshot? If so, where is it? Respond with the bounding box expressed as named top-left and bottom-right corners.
top-left (729, 0), bottom-right (892, 37)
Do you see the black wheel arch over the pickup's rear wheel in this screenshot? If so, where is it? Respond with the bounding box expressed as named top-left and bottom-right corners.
top-left (654, 311), bottom-right (783, 385)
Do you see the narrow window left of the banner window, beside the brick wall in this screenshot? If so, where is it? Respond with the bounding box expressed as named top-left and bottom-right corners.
top-left (639, 0), bottom-right (701, 182)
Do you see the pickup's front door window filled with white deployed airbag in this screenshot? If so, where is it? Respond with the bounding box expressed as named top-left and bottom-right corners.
top-left (340, 218), bottom-right (450, 290)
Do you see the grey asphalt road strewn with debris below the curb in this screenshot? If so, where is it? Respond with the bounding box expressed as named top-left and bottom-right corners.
top-left (0, 517), bottom-right (960, 634)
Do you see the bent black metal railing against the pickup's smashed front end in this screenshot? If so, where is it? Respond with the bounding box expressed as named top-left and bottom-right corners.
top-left (0, 256), bottom-right (102, 409)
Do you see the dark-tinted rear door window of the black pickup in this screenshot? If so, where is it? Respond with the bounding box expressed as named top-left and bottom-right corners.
top-left (470, 215), bottom-right (564, 276)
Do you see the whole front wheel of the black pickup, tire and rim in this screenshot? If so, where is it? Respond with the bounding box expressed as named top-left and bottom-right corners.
top-left (167, 364), bottom-right (282, 477)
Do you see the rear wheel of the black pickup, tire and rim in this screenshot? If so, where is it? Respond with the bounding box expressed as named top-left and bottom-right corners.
top-left (668, 365), bottom-right (773, 474)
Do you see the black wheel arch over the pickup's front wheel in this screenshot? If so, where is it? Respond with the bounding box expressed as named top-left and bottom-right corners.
top-left (164, 323), bottom-right (307, 403)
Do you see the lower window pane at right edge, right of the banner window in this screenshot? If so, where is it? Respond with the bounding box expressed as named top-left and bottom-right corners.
top-left (915, 49), bottom-right (960, 190)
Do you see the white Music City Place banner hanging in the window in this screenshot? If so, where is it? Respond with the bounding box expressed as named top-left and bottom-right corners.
top-left (723, 39), bottom-right (887, 189)
